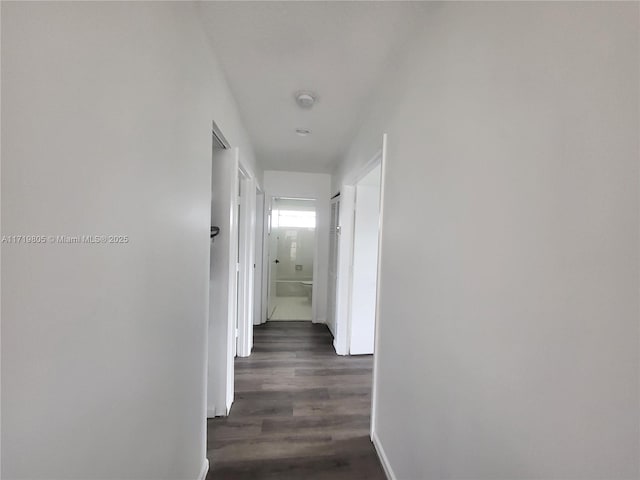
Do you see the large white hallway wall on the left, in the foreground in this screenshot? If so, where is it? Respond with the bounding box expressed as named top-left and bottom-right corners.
top-left (2, 2), bottom-right (254, 480)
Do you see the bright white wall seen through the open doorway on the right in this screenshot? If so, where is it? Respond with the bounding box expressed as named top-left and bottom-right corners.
top-left (349, 165), bottom-right (380, 355)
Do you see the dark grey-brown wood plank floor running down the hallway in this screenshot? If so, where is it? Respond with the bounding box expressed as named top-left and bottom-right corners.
top-left (207, 322), bottom-right (386, 480)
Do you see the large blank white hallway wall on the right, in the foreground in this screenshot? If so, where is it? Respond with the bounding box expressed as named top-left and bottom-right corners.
top-left (334, 2), bottom-right (640, 480)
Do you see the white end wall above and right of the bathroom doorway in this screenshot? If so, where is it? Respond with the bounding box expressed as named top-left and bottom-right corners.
top-left (264, 170), bottom-right (331, 323)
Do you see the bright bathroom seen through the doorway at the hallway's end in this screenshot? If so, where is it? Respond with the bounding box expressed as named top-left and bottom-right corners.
top-left (267, 197), bottom-right (316, 321)
